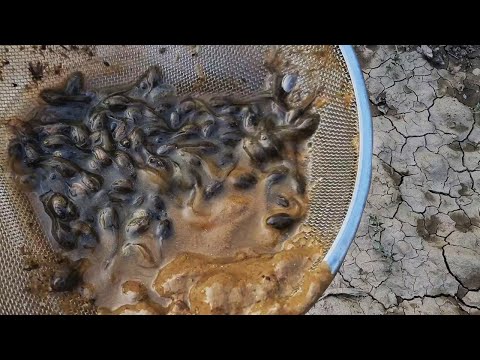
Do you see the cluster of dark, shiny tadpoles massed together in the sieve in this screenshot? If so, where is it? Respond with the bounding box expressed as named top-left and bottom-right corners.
top-left (9, 63), bottom-right (319, 292)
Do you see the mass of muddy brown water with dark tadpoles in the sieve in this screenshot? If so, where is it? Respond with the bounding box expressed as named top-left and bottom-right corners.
top-left (10, 62), bottom-right (331, 314)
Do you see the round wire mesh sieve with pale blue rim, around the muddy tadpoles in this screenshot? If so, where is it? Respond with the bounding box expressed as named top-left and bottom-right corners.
top-left (0, 45), bottom-right (372, 314)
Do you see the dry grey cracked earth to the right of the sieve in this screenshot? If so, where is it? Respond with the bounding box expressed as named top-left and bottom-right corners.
top-left (309, 45), bottom-right (480, 314)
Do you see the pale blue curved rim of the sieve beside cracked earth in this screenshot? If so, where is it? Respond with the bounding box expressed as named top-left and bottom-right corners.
top-left (325, 45), bottom-right (373, 274)
